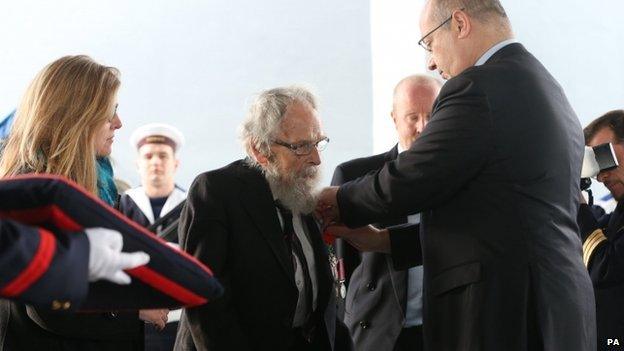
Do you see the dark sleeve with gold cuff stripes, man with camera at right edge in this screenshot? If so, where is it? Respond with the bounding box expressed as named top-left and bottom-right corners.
top-left (577, 204), bottom-right (624, 287)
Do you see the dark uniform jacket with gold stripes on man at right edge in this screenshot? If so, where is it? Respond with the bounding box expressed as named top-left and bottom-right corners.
top-left (578, 202), bottom-right (624, 350)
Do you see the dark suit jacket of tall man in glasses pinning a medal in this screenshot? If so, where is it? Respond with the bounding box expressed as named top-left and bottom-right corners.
top-left (338, 43), bottom-right (596, 351)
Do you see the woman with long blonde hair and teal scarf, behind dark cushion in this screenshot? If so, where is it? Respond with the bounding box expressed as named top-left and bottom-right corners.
top-left (0, 56), bottom-right (166, 351)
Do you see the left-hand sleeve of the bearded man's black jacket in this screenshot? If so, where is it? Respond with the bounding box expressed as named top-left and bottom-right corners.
top-left (179, 174), bottom-right (250, 350)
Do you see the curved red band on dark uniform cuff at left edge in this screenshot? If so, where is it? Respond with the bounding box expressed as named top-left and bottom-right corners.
top-left (0, 229), bottom-right (56, 297)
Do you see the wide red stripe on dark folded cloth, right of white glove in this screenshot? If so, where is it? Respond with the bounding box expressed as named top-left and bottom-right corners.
top-left (126, 266), bottom-right (208, 307)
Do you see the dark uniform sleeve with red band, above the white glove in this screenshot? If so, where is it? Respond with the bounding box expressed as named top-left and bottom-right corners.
top-left (0, 220), bottom-right (89, 309)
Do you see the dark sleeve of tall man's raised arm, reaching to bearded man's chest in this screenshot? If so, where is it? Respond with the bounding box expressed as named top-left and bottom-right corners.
top-left (338, 77), bottom-right (494, 227)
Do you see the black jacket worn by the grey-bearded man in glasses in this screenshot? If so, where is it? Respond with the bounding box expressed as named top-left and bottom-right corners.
top-left (175, 160), bottom-right (335, 351)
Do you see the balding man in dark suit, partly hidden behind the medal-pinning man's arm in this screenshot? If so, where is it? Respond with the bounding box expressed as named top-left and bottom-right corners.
top-left (332, 75), bottom-right (441, 351)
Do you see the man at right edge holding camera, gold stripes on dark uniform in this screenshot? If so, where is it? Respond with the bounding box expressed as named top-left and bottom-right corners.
top-left (578, 110), bottom-right (624, 350)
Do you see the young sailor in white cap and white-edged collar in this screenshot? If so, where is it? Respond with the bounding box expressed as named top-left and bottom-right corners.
top-left (119, 123), bottom-right (186, 242)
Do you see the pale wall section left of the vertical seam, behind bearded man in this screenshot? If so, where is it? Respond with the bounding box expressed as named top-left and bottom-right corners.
top-left (0, 0), bottom-right (372, 187)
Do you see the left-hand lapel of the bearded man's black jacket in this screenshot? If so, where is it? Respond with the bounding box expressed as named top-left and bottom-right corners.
top-left (240, 167), bottom-right (295, 285)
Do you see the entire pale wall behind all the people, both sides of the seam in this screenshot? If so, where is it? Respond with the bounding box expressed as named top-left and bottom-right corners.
top-left (0, 0), bottom-right (624, 201)
